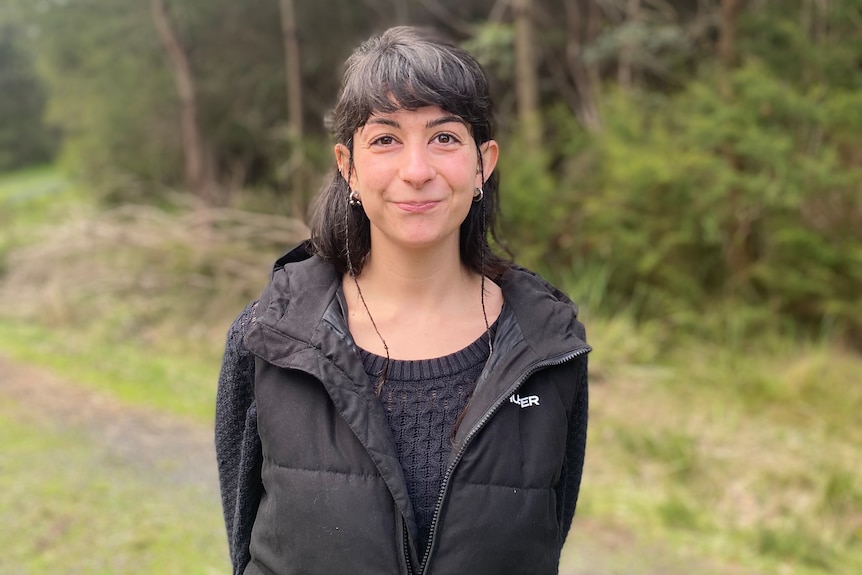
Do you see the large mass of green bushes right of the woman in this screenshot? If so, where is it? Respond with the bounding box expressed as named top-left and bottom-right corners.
top-left (496, 1), bottom-right (862, 344)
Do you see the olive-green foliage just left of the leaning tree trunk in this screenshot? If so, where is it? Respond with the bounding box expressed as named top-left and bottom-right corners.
top-left (13, 0), bottom-right (181, 197)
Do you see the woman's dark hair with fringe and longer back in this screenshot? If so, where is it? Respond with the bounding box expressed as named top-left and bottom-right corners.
top-left (311, 26), bottom-right (509, 279)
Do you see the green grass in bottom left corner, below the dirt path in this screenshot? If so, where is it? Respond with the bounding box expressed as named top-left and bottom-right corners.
top-left (0, 402), bottom-right (229, 575)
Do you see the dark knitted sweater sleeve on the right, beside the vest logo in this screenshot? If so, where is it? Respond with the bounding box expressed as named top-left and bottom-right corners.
top-left (556, 355), bottom-right (589, 543)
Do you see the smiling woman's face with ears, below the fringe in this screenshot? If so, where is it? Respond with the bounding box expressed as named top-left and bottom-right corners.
top-left (335, 106), bottom-right (498, 253)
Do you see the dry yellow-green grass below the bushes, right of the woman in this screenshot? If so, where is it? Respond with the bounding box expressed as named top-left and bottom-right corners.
top-left (576, 320), bottom-right (862, 575)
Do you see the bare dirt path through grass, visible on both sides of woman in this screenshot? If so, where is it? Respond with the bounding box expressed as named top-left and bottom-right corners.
top-left (0, 355), bottom-right (756, 575)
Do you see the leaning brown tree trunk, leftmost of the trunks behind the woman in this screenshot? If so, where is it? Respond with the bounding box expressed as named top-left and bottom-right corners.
top-left (150, 0), bottom-right (213, 203)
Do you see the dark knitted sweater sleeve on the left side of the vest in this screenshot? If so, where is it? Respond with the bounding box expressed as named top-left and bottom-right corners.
top-left (215, 303), bottom-right (263, 575)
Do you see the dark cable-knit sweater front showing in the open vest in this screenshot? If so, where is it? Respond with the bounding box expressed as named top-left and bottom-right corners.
top-left (359, 328), bottom-right (493, 557)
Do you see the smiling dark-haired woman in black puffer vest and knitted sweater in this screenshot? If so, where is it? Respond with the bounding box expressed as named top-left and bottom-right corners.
top-left (216, 28), bottom-right (589, 575)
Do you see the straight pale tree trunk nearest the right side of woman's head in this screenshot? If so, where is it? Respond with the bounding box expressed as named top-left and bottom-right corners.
top-left (512, 0), bottom-right (542, 149)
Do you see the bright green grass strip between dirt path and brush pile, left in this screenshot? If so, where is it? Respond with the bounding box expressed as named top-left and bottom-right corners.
top-left (0, 319), bottom-right (220, 422)
